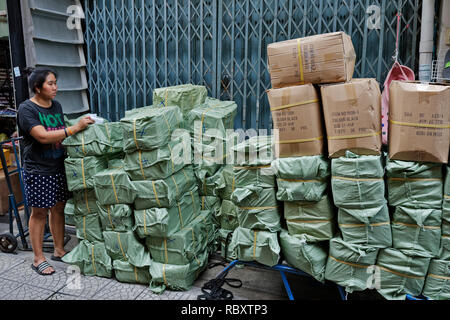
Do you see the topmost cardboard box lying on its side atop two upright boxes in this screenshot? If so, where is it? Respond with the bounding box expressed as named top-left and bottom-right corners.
top-left (267, 32), bottom-right (356, 88)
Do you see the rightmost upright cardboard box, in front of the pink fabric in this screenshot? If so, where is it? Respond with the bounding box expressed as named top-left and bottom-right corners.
top-left (389, 81), bottom-right (450, 163)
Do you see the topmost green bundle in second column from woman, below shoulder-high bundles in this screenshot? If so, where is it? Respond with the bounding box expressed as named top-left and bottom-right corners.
top-left (94, 168), bottom-right (137, 205)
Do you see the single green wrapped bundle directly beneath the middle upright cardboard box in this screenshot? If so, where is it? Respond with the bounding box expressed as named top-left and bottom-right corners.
top-left (331, 151), bottom-right (386, 209)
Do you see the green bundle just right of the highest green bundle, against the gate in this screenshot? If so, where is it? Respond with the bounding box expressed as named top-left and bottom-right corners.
top-left (186, 99), bottom-right (237, 139)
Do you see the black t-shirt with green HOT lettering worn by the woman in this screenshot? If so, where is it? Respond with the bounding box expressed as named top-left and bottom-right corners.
top-left (17, 100), bottom-right (66, 175)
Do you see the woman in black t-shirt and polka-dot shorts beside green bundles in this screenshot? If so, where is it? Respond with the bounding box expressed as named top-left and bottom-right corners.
top-left (17, 68), bottom-right (94, 275)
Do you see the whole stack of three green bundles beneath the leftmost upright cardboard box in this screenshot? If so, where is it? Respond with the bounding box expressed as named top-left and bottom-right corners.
top-left (272, 155), bottom-right (335, 282)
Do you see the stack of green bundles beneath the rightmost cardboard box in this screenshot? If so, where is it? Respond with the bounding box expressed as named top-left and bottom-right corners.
top-left (377, 159), bottom-right (448, 300)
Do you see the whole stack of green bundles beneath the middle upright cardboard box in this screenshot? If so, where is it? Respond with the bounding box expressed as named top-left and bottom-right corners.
top-left (325, 151), bottom-right (392, 292)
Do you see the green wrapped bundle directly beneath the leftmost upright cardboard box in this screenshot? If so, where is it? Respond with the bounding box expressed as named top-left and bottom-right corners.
top-left (272, 156), bottom-right (331, 202)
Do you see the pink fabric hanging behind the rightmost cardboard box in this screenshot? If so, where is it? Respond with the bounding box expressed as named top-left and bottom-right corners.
top-left (381, 61), bottom-right (415, 145)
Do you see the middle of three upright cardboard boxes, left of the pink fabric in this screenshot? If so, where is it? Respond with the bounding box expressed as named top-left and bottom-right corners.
top-left (321, 79), bottom-right (381, 158)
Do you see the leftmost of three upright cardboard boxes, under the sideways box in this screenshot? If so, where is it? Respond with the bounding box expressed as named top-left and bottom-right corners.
top-left (267, 84), bottom-right (324, 158)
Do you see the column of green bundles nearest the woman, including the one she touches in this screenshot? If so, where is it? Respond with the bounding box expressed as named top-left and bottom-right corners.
top-left (63, 120), bottom-right (123, 277)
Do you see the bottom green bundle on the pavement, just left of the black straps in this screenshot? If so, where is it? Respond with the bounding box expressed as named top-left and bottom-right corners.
top-left (150, 251), bottom-right (208, 294)
